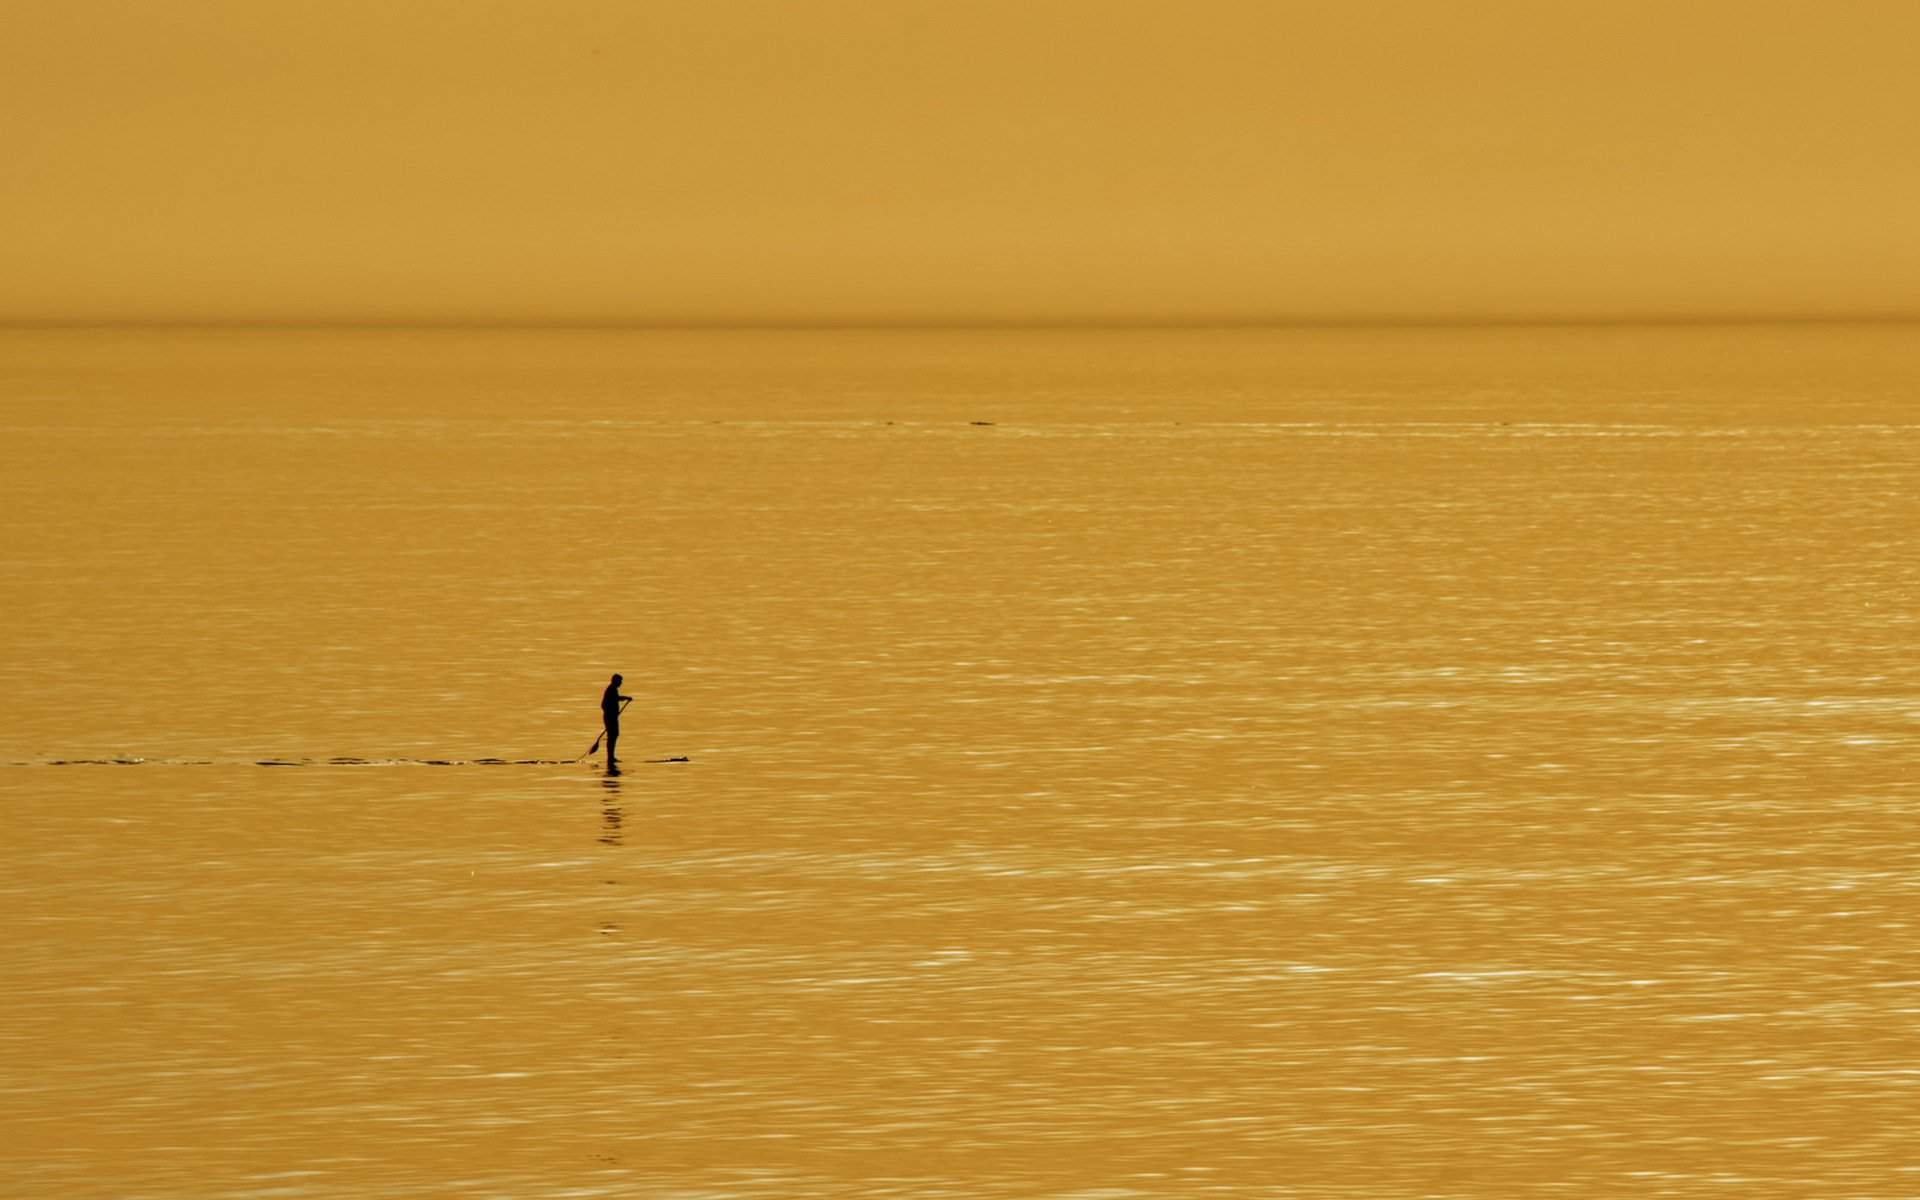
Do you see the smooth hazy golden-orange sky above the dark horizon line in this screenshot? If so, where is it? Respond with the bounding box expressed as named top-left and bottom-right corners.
top-left (0, 0), bottom-right (1920, 324)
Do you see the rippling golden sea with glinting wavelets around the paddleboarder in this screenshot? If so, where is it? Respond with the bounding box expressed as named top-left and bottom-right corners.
top-left (0, 324), bottom-right (1920, 1200)
